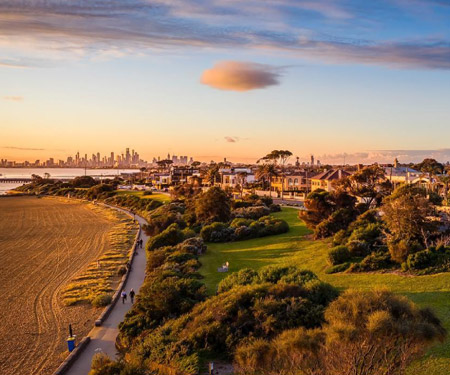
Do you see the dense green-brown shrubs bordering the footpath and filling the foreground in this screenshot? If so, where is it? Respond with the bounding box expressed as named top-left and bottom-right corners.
top-left (86, 185), bottom-right (445, 375)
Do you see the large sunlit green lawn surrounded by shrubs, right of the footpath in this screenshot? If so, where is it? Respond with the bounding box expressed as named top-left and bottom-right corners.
top-left (200, 208), bottom-right (450, 375)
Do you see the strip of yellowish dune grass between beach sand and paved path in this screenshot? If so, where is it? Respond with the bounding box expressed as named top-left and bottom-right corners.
top-left (62, 204), bottom-right (137, 306)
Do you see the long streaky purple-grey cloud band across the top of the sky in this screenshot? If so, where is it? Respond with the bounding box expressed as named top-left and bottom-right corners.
top-left (0, 0), bottom-right (450, 69)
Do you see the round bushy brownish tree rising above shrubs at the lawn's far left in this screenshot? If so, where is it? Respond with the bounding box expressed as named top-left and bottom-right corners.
top-left (194, 187), bottom-right (231, 224)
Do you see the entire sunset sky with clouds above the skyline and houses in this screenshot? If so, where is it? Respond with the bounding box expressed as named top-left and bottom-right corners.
top-left (0, 0), bottom-right (450, 163)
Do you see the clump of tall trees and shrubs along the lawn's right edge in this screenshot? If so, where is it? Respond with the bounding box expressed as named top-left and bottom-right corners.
top-left (299, 166), bottom-right (450, 274)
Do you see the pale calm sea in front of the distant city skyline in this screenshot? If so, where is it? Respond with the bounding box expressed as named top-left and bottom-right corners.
top-left (0, 168), bottom-right (138, 195)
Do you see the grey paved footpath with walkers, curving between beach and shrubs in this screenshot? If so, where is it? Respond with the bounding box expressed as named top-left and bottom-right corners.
top-left (66, 215), bottom-right (148, 375)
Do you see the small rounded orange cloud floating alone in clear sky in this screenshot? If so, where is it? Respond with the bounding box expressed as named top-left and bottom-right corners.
top-left (200, 61), bottom-right (280, 91)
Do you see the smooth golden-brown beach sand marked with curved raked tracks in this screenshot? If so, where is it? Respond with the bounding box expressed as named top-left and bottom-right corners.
top-left (0, 197), bottom-right (125, 375)
